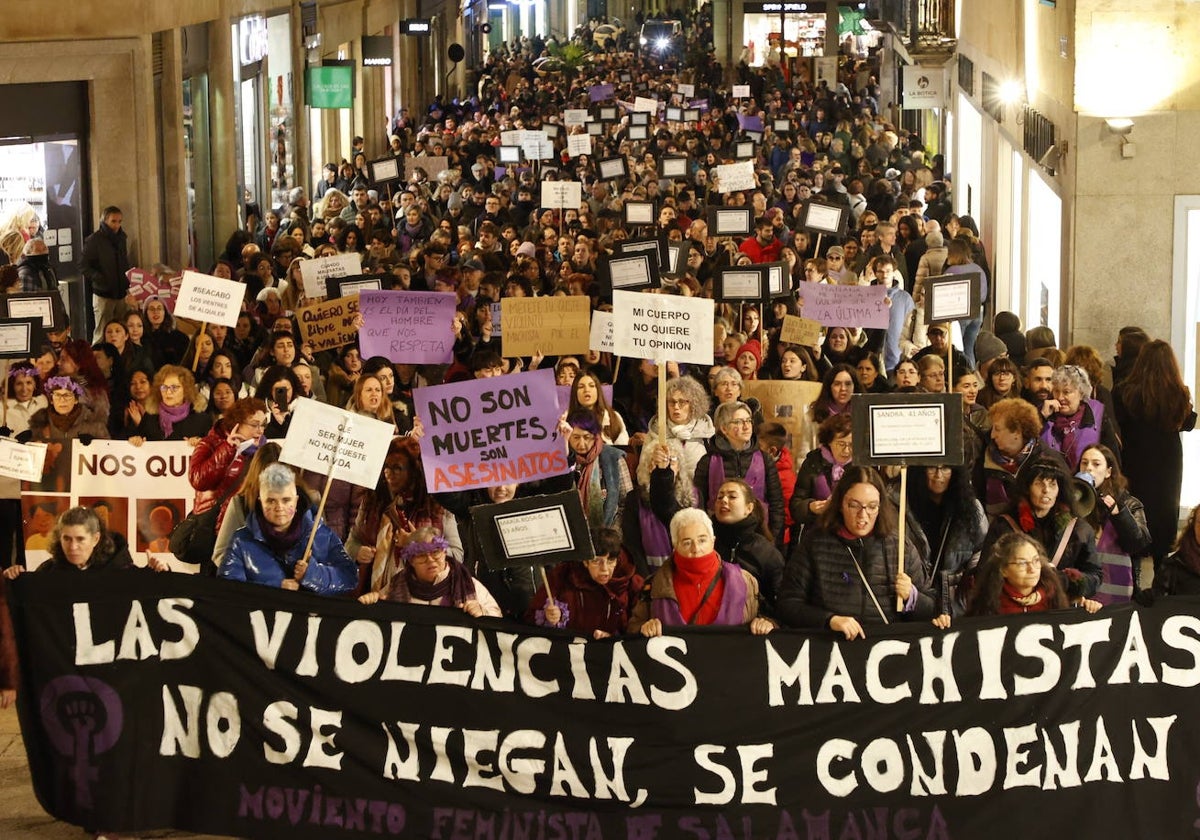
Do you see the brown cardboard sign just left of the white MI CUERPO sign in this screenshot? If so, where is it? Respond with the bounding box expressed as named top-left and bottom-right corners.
top-left (500, 295), bottom-right (592, 356)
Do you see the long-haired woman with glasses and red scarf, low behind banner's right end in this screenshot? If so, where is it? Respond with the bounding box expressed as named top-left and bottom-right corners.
top-left (966, 532), bottom-right (1067, 616)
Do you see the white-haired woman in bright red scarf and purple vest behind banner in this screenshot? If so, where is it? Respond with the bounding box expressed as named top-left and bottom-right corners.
top-left (628, 508), bottom-right (776, 637)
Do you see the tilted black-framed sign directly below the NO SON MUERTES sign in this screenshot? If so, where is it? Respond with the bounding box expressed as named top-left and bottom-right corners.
top-left (470, 490), bottom-right (595, 571)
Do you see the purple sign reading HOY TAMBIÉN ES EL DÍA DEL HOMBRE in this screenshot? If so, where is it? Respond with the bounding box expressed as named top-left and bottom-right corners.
top-left (359, 290), bottom-right (458, 365)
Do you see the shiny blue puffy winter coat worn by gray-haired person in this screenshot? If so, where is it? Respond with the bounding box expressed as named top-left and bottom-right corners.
top-left (217, 510), bottom-right (359, 595)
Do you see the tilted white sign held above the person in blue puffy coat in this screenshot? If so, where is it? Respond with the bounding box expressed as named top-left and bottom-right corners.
top-left (280, 397), bottom-right (396, 490)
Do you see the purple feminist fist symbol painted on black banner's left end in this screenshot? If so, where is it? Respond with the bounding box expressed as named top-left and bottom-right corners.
top-left (41, 674), bottom-right (124, 810)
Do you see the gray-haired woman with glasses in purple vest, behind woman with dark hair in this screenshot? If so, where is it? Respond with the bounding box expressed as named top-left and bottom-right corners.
top-left (696, 402), bottom-right (784, 546)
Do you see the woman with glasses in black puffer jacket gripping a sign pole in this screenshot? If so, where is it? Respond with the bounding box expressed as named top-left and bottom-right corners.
top-left (779, 467), bottom-right (937, 641)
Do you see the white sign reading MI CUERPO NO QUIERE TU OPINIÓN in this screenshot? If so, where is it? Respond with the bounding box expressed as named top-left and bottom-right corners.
top-left (612, 289), bottom-right (713, 365)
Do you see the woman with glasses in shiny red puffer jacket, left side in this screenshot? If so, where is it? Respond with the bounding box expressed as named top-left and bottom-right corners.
top-left (187, 397), bottom-right (266, 515)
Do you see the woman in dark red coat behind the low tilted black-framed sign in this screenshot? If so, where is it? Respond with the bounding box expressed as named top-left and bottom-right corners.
top-left (524, 528), bottom-right (643, 638)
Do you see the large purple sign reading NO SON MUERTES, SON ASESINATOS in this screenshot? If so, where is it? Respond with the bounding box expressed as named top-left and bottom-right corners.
top-left (413, 370), bottom-right (570, 493)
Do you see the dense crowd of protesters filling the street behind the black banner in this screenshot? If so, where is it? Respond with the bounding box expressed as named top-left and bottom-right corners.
top-left (0, 19), bottom-right (1200, 720)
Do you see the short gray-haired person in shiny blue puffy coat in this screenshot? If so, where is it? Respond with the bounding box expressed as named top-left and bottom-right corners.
top-left (217, 463), bottom-right (359, 595)
